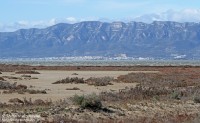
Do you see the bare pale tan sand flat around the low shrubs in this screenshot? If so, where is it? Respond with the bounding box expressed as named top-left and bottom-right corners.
top-left (0, 70), bottom-right (158, 102)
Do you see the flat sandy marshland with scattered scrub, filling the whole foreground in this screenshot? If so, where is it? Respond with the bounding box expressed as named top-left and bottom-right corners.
top-left (0, 64), bottom-right (200, 123)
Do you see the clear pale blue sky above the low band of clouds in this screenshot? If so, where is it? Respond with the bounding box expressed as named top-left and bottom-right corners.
top-left (0, 0), bottom-right (200, 23)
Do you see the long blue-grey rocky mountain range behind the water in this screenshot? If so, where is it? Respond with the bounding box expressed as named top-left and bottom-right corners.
top-left (0, 21), bottom-right (200, 59)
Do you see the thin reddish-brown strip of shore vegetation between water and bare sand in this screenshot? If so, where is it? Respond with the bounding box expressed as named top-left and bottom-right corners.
top-left (0, 64), bottom-right (200, 72)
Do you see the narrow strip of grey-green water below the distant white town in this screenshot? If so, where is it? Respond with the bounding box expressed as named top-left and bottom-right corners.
top-left (0, 59), bottom-right (200, 66)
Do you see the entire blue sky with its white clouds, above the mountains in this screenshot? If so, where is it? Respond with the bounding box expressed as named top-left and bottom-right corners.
top-left (0, 0), bottom-right (200, 31)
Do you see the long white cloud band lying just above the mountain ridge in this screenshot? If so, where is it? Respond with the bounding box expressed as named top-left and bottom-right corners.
top-left (0, 9), bottom-right (200, 32)
